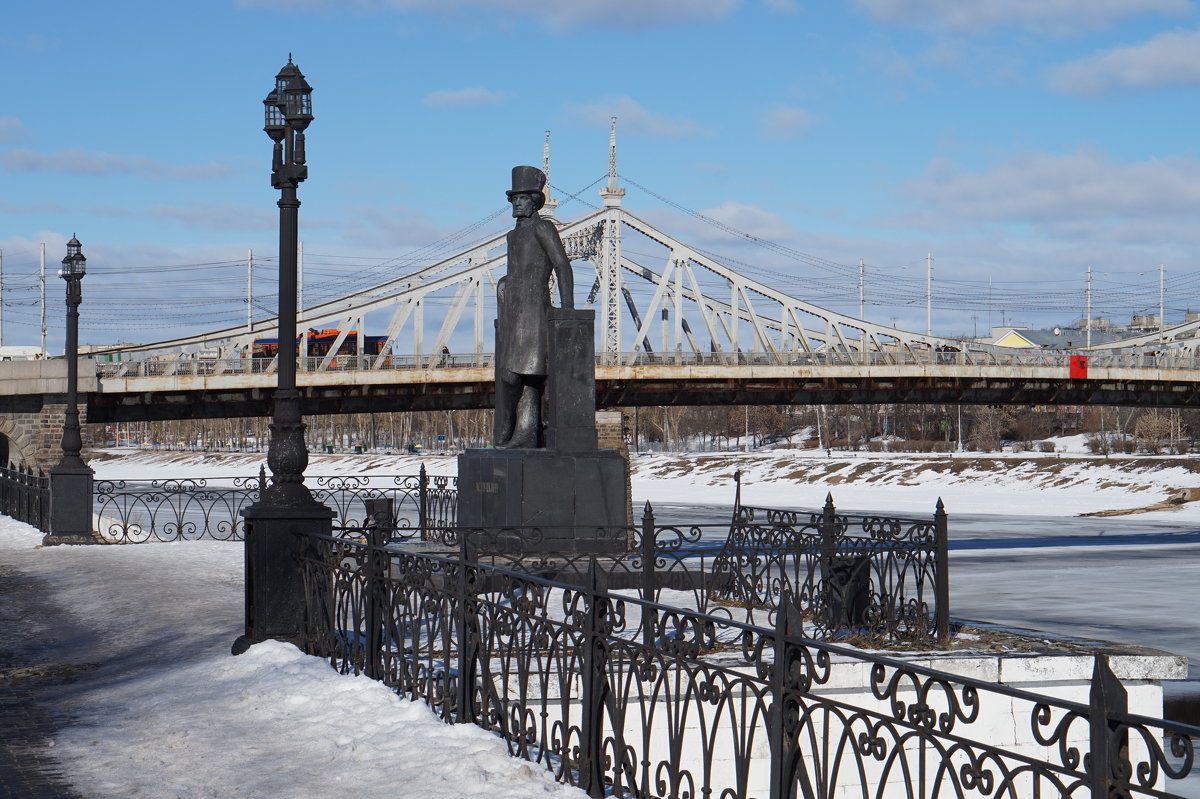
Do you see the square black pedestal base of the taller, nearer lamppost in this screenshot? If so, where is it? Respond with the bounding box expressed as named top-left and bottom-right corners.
top-left (232, 495), bottom-right (334, 655)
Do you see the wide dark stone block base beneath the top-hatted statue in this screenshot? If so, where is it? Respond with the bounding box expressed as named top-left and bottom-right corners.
top-left (458, 448), bottom-right (626, 553)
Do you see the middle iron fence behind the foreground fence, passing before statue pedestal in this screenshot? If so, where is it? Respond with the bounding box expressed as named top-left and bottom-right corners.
top-left (360, 498), bottom-right (950, 647)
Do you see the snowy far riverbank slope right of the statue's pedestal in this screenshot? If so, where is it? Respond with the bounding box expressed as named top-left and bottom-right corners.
top-left (632, 450), bottom-right (1200, 519)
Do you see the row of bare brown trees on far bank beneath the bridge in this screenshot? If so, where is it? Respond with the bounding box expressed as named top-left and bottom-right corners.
top-left (88, 404), bottom-right (1200, 455)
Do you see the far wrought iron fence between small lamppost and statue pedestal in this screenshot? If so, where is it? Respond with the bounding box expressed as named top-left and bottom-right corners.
top-left (92, 465), bottom-right (457, 543)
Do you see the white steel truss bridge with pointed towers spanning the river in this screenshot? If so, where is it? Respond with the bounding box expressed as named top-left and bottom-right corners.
top-left (58, 170), bottom-right (1200, 421)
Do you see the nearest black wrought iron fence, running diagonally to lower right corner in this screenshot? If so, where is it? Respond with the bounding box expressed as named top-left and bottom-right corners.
top-left (301, 534), bottom-right (1200, 799)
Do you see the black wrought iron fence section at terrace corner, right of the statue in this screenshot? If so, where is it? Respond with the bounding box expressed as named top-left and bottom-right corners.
top-left (713, 473), bottom-right (950, 642)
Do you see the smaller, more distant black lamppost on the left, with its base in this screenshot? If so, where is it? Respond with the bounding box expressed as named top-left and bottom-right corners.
top-left (42, 236), bottom-right (95, 545)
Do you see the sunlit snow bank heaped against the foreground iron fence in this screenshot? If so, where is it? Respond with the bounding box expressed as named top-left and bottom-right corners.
top-left (56, 641), bottom-right (583, 799)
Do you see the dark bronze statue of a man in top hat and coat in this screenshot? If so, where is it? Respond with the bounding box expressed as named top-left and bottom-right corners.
top-left (496, 167), bottom-right (575, 449)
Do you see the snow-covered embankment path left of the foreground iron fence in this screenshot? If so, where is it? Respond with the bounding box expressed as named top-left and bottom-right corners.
top-left (0, 517), bottom-right (584, 799)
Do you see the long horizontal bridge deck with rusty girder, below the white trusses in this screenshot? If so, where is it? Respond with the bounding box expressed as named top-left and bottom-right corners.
top-left (7, 353), bottom-right (1200, 422)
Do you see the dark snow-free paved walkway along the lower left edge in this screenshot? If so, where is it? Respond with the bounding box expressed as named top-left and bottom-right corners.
top-left (0, 565), bottom-right (80, 799)
